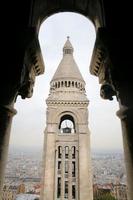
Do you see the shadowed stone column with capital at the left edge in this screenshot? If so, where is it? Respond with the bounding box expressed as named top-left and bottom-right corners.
top-left (0, 105), bottom-right (17, 194)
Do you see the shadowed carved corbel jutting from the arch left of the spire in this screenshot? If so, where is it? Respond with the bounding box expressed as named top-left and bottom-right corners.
top-left (18, 30), bottom-right (44, 99)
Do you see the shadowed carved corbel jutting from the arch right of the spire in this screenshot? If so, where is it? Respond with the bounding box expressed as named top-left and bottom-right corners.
top-left (90, 28), bottom-right (116, 100)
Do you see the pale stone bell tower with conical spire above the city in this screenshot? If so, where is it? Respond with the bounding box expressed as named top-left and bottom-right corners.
top-left (42, 37), bottom-right (93, 200)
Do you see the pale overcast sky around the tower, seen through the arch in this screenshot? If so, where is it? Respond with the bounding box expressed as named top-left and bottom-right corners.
top-left (10, 13), bottom-right (123, 150)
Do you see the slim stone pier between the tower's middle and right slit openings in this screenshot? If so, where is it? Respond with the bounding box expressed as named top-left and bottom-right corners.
top-left (68, 147), bottom-right (72, 200)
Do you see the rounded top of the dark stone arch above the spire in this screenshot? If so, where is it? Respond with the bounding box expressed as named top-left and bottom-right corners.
top-left (30, 0), bottom-right (104, 31)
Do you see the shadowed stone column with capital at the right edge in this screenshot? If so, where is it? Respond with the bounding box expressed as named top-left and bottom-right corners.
top-left (117, 105), bottom-right (133, 200)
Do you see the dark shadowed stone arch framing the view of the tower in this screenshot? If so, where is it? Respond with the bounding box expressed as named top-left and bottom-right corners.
top-left (0, 0), bottom-right (133, 200)
